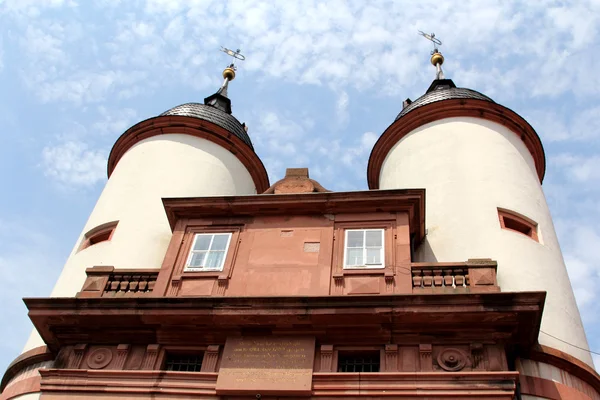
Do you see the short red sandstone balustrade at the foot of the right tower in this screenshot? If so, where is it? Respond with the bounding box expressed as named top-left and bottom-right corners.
top-left (411, 259), bottom-right (500, 293)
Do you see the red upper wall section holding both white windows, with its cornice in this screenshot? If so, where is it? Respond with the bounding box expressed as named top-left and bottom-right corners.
top-left (153, 189), bottom-right (425, 296)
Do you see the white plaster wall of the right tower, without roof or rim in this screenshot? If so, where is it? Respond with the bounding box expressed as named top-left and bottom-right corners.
top-left (380, 117), bottom-right (593, 365)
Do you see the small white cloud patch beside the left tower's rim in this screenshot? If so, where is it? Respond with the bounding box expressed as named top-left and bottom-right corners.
top-left (42, 140), bottom-right (107, 187)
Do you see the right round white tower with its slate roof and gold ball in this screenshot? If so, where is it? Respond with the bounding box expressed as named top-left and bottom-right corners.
top-left (368, 53), bottom-right (593, 390)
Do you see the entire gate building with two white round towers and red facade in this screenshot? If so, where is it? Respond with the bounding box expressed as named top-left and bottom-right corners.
top-left (0, 51), bottom-right (600, 400)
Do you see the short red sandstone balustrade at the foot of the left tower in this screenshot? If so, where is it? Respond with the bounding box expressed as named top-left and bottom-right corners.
top-left (77, 267), bottom-right (158, 297)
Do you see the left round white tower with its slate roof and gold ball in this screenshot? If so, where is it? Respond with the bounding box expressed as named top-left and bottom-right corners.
top-left (24, 68), bottom-right (269, 351)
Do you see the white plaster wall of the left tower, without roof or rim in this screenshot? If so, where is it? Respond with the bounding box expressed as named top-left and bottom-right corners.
top-left (24, 134), bottom-right (256, 351)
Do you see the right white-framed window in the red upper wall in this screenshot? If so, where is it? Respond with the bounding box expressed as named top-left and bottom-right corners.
top-left (344, 229), bottom-right (384, 268)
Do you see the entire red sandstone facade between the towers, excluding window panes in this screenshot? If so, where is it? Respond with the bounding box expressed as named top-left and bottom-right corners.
top-left (2, 170), bottom-right (600, 400)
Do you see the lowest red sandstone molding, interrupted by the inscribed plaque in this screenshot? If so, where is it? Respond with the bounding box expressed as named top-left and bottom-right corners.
top-left (40, 369), bottom-right (519, 400)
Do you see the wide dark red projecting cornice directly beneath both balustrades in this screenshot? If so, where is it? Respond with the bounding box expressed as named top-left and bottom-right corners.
top-left (24, 290), bottom-right (545, 351)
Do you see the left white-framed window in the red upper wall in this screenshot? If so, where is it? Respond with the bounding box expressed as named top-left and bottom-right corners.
top-left (185, 233), bottom-right (231, 271)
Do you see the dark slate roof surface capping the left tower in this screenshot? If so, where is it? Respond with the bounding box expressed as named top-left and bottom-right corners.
top-left (160, 103), bottom-right (254, 149)
